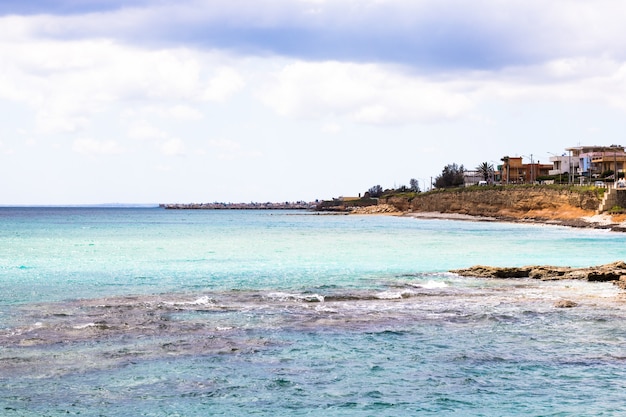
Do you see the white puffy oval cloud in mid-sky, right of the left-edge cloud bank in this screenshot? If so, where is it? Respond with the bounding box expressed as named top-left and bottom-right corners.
top-left (260, 62), bottom-right (472, 124)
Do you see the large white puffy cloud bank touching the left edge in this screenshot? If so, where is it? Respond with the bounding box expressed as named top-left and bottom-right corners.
top-left (0, 35), bottom-right (243, 133)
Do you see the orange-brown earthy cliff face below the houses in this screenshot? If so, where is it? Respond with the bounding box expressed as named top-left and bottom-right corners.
top-left (383, 187), bottom-right (600, 220)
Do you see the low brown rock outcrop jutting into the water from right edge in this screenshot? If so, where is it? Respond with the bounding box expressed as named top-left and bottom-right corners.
top-left (450, 261), bottom-right (626, 289)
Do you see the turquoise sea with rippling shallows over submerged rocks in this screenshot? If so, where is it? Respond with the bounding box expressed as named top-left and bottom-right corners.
top-left (0, 207), bottom-right (626, 417)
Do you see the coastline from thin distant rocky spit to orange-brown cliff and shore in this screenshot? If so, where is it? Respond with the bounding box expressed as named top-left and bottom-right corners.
top-left (159, 186), bottom-right (626, 232)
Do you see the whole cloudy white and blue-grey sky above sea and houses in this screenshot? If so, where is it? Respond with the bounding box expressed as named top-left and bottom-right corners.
top-left (0, 0), bottom-right (626, 205)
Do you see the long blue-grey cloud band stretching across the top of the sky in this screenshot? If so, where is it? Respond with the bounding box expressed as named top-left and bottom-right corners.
top-left (0, 0), bottom-right (626, 71)
